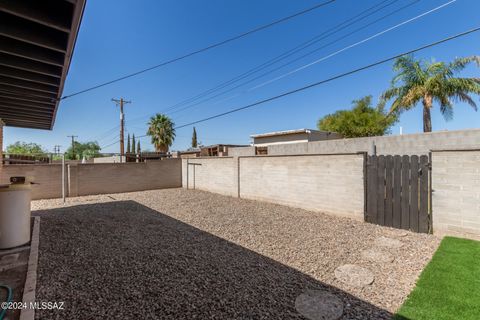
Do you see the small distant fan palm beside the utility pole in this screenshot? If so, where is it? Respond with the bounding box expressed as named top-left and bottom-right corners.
top-left (147, 113), bottom-right (175, 152)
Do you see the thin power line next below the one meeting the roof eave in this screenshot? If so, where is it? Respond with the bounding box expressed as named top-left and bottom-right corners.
top-left (162, 0), bottom-right (399, 112)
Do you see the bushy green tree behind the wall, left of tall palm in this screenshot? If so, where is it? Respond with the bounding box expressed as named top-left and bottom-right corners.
top-left (317, 96), bottom-right (397, 138)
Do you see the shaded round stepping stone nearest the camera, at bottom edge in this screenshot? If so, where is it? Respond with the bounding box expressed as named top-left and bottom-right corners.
top-left (295, 290), bottom-right (343, 320)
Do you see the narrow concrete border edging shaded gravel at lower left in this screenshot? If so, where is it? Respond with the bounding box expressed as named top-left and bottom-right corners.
top-left (20, 217), bottom-right (40, 320)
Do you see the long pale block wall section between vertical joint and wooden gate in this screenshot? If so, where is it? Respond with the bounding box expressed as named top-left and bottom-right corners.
top-left (240, 154), bottom-right (364, 220)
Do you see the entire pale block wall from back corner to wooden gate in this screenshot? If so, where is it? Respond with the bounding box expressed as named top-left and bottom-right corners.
top-left (182, 154), bottom-right (365, 220)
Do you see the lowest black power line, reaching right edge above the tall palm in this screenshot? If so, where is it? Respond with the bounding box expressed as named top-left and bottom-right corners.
top-left (169, 27), bottom-right (480, 129)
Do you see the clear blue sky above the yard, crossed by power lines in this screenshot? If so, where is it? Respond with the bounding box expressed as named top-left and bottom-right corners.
top-left (4, 0), bottom-right (480, 152)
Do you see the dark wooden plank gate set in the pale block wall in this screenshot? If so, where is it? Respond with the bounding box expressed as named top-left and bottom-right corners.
top-left (365, 155), bottom-right (431, 233)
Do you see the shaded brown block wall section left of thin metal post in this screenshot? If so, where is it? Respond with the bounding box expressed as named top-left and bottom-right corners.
top-left (0, 164), bottom-right (62, 200)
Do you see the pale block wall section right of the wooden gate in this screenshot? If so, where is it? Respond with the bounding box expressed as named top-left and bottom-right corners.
top-left (432, 151), bottom-right (480, 240)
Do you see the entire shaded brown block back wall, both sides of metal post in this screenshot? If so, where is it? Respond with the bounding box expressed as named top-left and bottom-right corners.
top-left (1, 159), bottom-right (182, 200)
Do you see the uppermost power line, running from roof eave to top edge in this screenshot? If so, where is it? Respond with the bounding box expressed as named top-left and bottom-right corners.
top-left (60, 0), bottom-right (336, 100)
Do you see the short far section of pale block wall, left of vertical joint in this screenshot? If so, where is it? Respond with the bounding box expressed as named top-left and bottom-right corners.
top-left (182, 157), bottom-right (238, 196)
